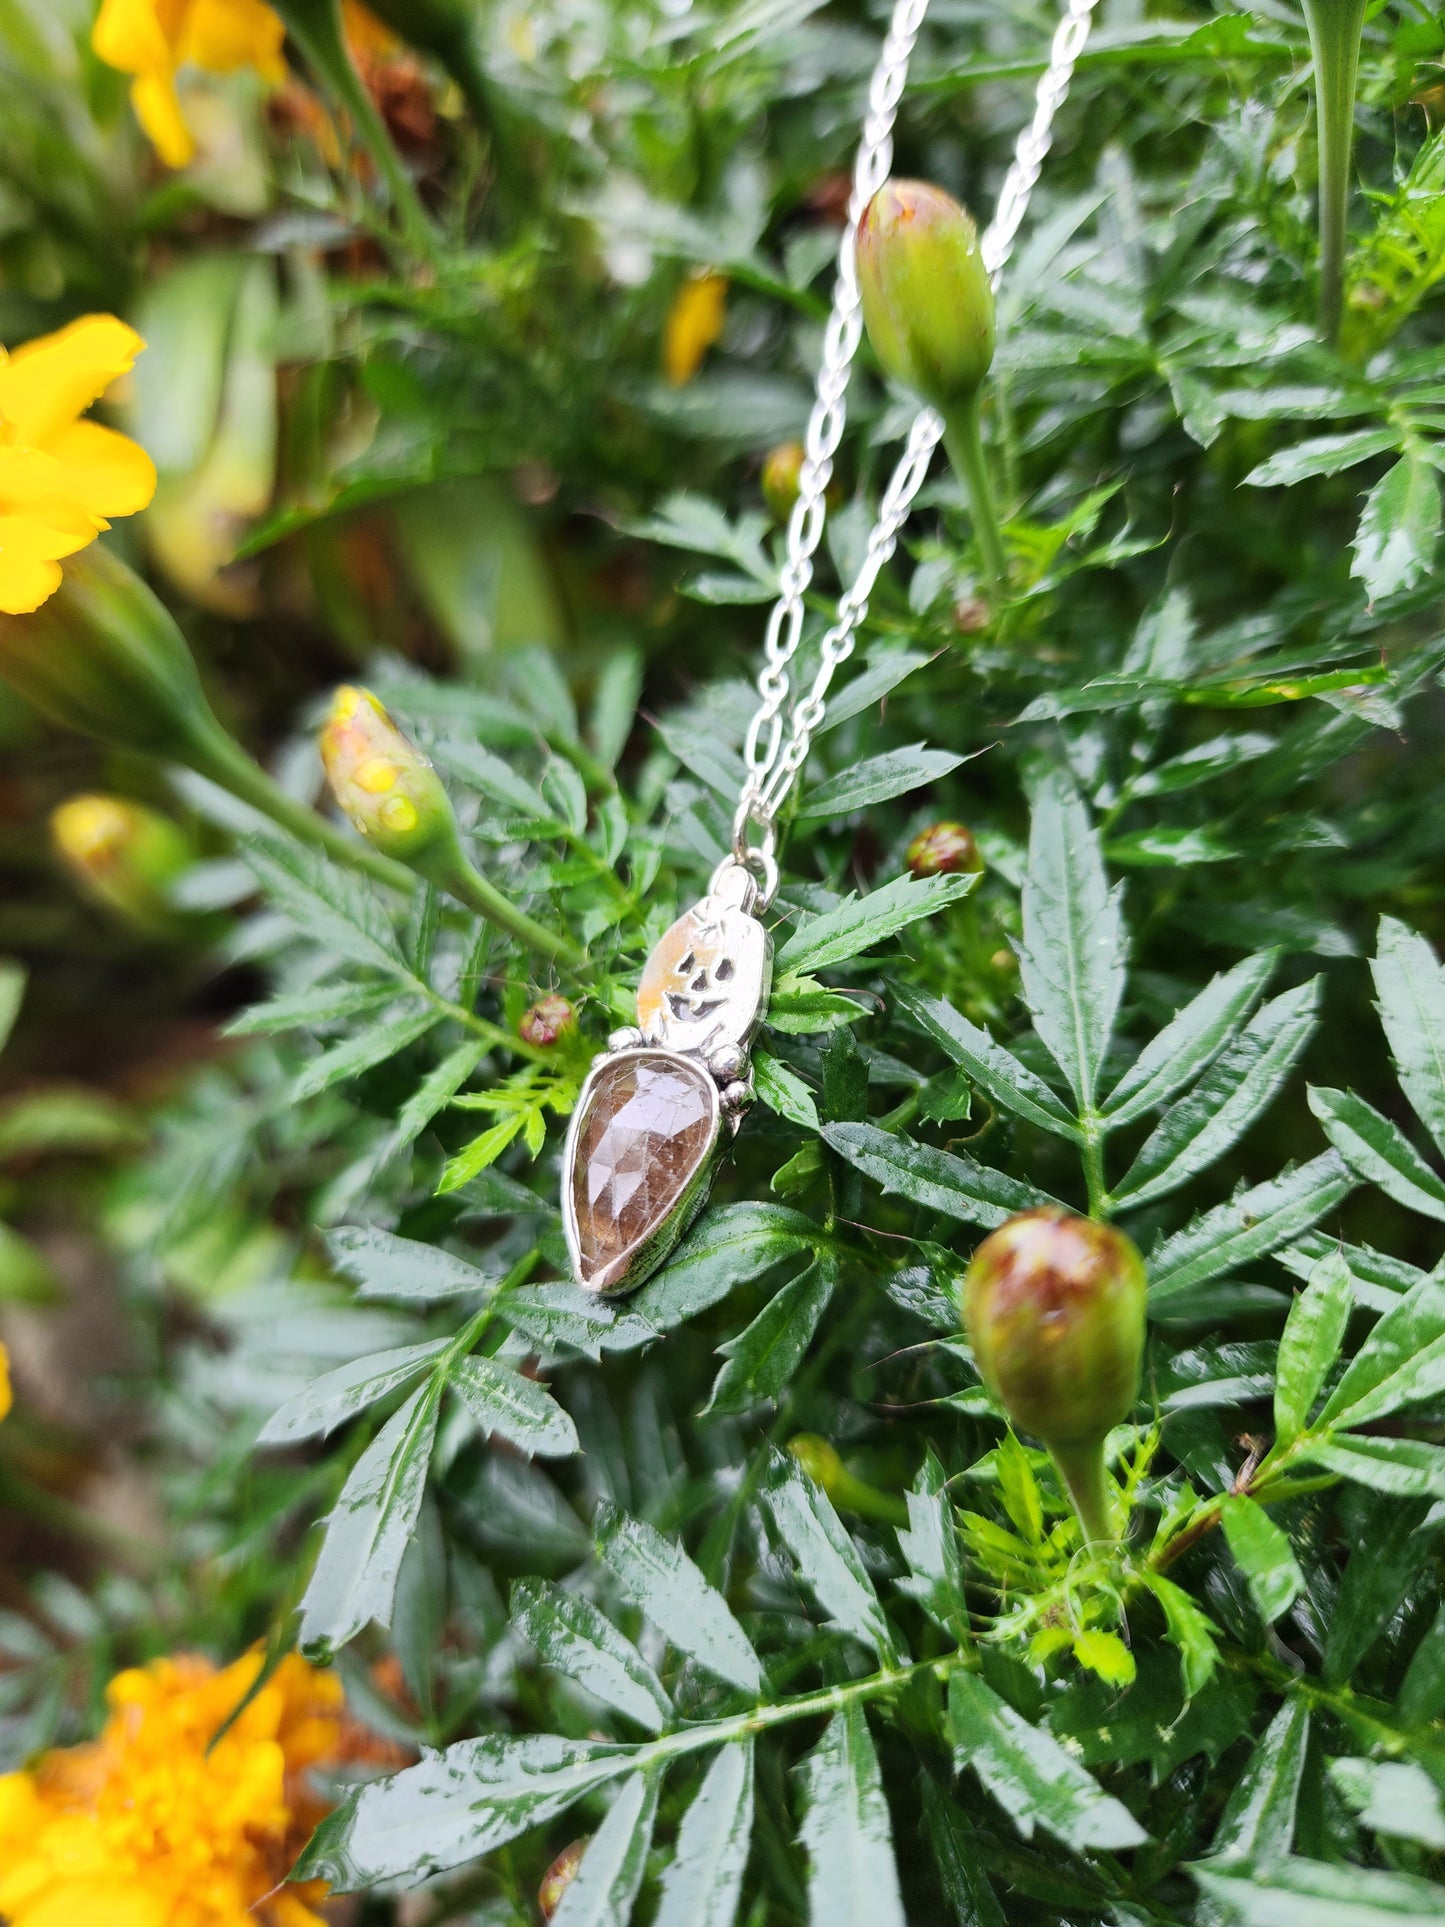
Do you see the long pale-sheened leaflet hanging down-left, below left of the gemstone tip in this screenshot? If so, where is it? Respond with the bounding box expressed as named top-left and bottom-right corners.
top-left (301, 1386), bottom-right (439, 1661)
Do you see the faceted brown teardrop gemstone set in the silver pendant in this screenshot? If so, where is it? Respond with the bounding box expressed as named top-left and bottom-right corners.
top-left (570, 1050), bottom-right (717, 1291)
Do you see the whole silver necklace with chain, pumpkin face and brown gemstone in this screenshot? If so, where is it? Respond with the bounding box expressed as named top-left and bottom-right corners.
top-left (563, 0), bottom-right (1098, 1291)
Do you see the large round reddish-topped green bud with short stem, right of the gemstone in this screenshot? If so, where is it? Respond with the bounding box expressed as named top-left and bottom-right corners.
top-left (963, 1204), bottom-right (1146, 1540)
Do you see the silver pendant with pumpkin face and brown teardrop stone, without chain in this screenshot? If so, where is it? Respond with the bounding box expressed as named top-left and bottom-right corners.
top-left (563, 858), bottom-right (771, 1291)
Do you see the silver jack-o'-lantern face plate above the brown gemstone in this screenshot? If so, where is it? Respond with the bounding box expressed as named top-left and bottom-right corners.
top-left (638, 896), bottom-right (767, 1052)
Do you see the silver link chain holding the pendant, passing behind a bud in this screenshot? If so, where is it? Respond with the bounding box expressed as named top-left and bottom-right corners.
top-left (732, 0), bottom-right (1098, 908)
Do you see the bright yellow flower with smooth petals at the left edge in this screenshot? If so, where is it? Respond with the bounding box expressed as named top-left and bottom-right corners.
top-left (0, 314), bottom-right (156, 615)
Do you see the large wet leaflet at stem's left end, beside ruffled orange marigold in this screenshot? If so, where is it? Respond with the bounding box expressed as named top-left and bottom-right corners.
top-left (293, 1732), bottom-right (638, 1894)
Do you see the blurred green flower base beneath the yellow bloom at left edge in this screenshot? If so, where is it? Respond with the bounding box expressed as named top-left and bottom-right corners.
top-left (0, 543), bottom-right (220, 761)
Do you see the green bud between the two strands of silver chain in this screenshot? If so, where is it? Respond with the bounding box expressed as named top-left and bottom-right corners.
top-left (857, 181), bottom-right (994, 410)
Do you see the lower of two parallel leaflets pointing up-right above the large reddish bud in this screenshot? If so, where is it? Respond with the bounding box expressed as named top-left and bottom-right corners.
top-left (1114, 977), bottom-right (1320, 1208)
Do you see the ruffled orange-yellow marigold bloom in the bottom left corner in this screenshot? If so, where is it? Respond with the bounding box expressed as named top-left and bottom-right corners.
top-left (0, 1653), bottom-right (343, 1927)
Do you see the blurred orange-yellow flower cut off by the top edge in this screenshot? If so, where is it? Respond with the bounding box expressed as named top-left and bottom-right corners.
top-left (91, 0), bottom-right (285, 168)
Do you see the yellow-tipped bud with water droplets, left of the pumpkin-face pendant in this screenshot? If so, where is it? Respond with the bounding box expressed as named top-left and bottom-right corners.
top-left (320, 684), bottom-right (460, 877)
